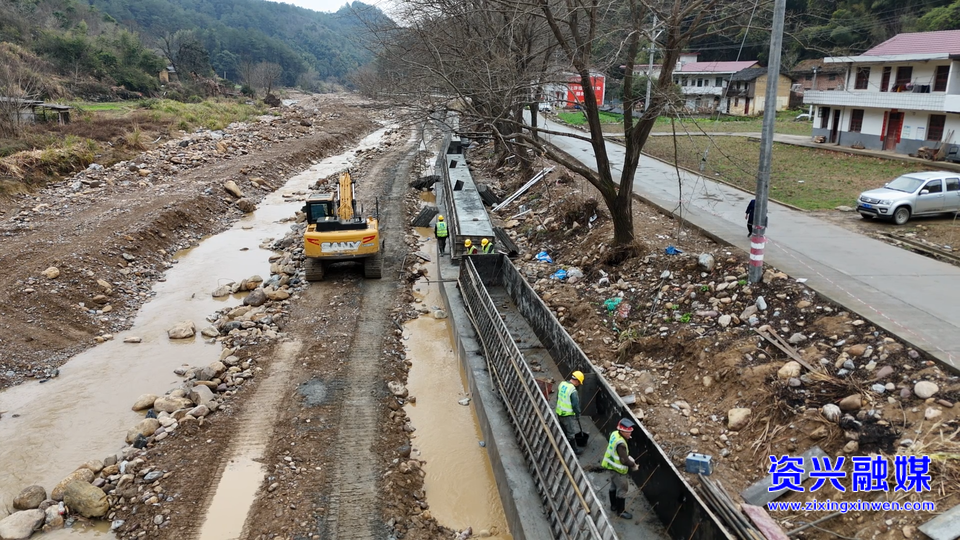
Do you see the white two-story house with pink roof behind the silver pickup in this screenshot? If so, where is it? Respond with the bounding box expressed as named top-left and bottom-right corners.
top-left (803, 30), bottom-right (960, 154)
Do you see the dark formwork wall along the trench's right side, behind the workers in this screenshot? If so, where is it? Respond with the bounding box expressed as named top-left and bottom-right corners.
top-left (473, 255), bottom-right (733, 540)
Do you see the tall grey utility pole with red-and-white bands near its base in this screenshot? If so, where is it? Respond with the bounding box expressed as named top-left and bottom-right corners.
top-left (749, 0), bottom-right (787, 283)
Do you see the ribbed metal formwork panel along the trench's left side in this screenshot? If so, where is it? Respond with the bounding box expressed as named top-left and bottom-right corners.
top-left (459, 256), bottom-right (617, 540)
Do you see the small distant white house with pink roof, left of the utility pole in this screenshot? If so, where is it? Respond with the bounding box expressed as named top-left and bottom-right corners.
top-left (673, 53), bottom-right (757, 114)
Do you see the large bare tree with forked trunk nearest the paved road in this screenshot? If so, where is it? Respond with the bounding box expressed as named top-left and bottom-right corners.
top-left (376, 0), bottom-right (754, 247)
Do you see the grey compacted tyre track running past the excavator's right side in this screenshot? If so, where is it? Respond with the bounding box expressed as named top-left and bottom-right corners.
top-left (325, 127), bottom-right (416, 540)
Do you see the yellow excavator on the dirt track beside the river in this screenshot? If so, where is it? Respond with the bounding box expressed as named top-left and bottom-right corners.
top-left (303, 171), bottom-right (383, 281)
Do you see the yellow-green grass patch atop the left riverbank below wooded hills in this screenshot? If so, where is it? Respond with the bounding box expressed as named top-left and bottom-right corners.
top-left (141, 99), bottom-right (264, 131)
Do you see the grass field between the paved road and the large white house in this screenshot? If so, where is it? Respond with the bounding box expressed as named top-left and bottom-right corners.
top-left (643, 136), bottom-right (933, 210)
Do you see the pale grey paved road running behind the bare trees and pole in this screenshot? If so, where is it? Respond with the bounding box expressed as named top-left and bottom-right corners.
top-left (547, 117), bottom-right (960, 371)
